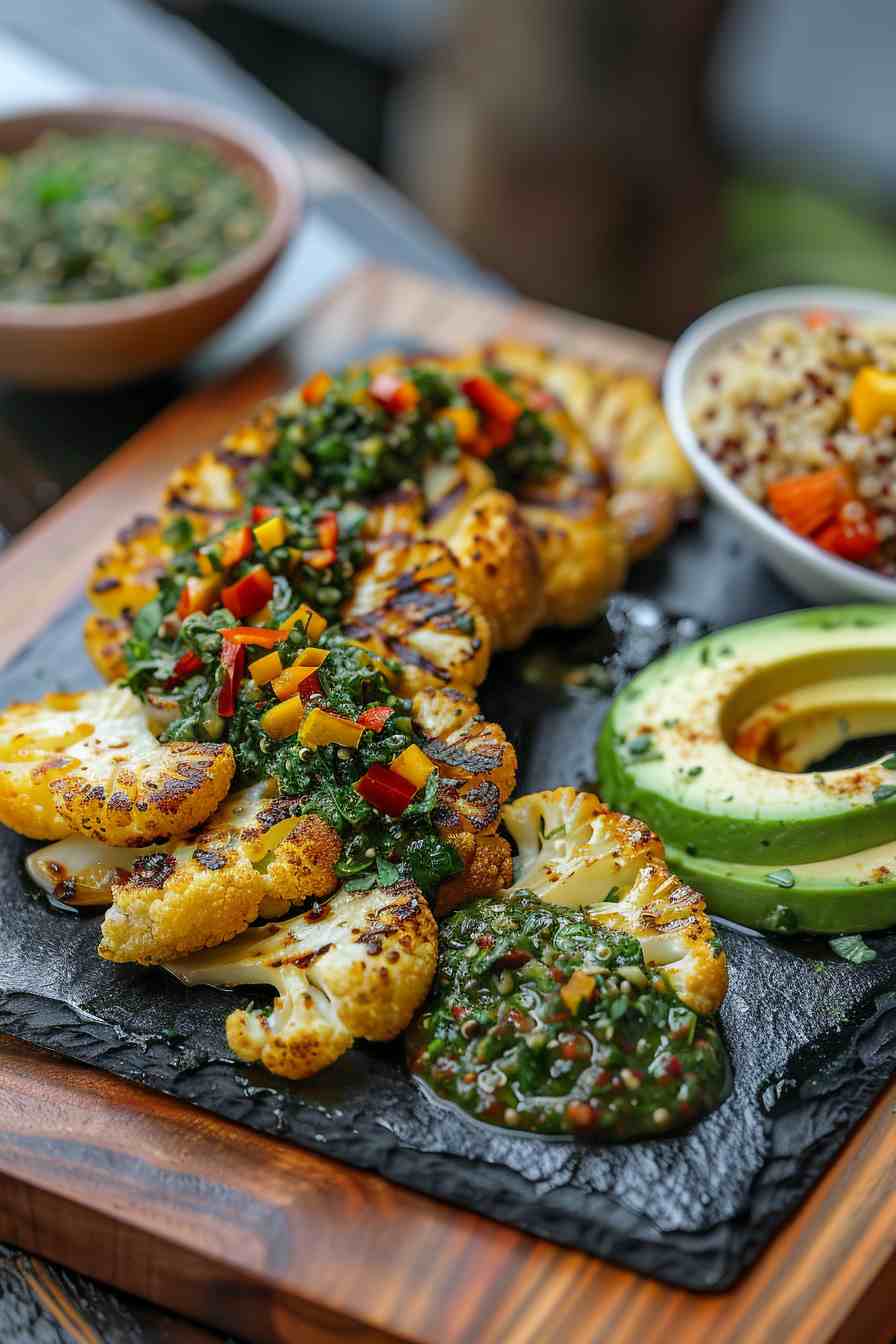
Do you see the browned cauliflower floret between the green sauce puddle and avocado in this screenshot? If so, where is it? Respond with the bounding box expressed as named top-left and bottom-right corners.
top-left (502, 789), bottom-right (728, 1013)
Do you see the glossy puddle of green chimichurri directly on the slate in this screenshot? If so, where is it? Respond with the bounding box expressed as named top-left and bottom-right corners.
top-left (408, 891), bottom-right (727, 1140)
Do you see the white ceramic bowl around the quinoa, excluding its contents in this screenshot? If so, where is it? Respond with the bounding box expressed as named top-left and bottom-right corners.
top-left (662, 285), bottom-right (896, 602)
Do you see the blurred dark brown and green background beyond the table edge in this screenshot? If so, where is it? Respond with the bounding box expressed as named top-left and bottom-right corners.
top-left (159, 0), bottom-right (896, 336)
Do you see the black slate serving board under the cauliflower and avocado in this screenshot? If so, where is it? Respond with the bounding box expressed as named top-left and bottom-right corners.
top-left (0, 534), bottom-right (896, 1289)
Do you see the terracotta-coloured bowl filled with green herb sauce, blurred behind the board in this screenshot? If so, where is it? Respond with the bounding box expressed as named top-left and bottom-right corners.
top-left (0, 98), bottom-right (301, 387)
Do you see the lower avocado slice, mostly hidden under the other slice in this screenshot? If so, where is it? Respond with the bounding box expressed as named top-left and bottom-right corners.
top-left (666, 840), bottom-right (896, 934)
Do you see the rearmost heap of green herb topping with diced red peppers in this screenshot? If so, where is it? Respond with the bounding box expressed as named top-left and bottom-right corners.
top-left (251, 364), bottom-right (560, 504)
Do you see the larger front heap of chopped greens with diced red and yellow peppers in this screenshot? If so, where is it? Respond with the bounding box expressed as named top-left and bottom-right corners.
top-left (125, 500), bottom-right (462, 894)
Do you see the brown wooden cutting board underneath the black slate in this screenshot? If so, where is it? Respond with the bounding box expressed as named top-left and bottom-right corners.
top-left (0, 269), bottom-right (896, 1344)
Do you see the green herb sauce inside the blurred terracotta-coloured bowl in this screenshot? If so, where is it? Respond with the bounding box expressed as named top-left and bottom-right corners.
top-left (0, 132), bottom-right (265, 304)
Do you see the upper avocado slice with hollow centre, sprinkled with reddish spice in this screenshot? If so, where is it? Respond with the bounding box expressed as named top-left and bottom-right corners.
top-left (598, 605), bottom-right (896, 865)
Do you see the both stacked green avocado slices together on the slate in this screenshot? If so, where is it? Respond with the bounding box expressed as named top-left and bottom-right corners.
top-left (598, 606), bottom-right (896, 933)
